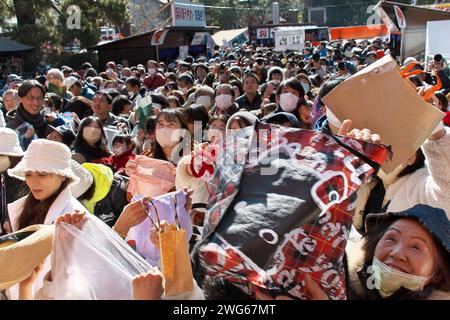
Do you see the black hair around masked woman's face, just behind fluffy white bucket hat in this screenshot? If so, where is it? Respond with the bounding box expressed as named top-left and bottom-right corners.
top-left (74, 116), bottom-right (111, 159)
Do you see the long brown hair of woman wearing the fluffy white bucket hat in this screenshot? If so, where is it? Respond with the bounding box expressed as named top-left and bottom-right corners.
top-left (17, 178), bottom-right (71, 230)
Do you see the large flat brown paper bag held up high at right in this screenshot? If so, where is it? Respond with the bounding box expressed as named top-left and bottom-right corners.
top-left (322, 55), bottom-right (445, 173)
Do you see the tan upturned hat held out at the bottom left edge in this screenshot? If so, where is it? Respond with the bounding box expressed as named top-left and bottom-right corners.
top-left (0, 225), bottom-right (55, 290)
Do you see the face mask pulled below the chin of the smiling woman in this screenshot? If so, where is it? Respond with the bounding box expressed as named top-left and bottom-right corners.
top-left (372, 257), bottom-right (434, 299)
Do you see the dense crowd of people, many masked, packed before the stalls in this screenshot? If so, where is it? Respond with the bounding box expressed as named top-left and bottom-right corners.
top-left (0, 38), bottom-right (450, 300)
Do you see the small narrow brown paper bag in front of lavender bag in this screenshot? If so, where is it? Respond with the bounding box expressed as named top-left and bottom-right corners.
top-left (159, 225), bottom-right (194, 296)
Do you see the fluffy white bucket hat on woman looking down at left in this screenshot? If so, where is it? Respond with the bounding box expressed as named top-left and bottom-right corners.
top-left (8, 139), bottom-right (79, 184)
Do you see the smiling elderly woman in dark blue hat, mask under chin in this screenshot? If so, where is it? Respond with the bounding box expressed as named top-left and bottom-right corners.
top-left (347, 205), bottom-right (450, 300)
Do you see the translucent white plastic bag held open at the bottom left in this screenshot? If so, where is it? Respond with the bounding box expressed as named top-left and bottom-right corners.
top-left (51, 215), bottom-right (152, 300)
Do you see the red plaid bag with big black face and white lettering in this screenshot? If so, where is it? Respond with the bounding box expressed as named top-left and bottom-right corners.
top-left (194, 125), bottom-right (388, 300)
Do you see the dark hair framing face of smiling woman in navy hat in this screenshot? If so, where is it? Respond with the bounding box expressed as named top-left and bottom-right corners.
top-left (362, 217), bottom-right (450, 300)
